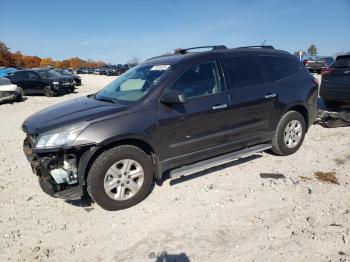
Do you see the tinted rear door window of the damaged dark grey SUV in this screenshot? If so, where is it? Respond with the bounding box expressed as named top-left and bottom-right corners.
top-left (223, 57), bottom-right (265, 88)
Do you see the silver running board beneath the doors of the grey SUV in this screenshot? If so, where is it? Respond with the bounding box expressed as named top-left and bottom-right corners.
top-left (169, 144), bottom-right (271, 178)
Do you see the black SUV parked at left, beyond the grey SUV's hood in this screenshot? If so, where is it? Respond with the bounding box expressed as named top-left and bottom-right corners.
top-left (9, 69), bottom-right (74, 97)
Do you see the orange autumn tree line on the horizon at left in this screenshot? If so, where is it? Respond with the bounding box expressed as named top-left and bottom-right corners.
top-left (0, 41), bottom-right (106, 68)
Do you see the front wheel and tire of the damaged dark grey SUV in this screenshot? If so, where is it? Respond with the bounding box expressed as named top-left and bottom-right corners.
top-left (87, 145), bottom-right (153, 211)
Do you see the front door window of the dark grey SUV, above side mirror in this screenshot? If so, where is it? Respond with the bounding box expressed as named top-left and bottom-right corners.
top-left (170, 62), bottom-right (222, 99)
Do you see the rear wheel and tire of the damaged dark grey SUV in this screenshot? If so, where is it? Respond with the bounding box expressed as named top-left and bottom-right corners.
top-left (272, 110), bottom-right (306, 156)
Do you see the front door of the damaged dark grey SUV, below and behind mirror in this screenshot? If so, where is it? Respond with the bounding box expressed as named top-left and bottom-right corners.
top-left (158, 61), bottom-right (231, 159)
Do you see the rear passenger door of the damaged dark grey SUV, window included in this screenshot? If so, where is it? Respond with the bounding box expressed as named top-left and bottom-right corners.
top-left (221, 56), bottom-right (278, 143)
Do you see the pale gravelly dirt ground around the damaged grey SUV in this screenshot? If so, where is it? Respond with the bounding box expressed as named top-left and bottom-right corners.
top-left (0, 76), bottom-right (350, 262)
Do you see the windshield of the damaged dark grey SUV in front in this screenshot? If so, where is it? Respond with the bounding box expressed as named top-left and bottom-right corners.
top-left (96, 65), bottom-right (170, 102)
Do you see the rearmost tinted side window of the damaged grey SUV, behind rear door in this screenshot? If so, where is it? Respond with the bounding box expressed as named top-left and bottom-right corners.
top-left (261, 56), bottom-right (301, 82)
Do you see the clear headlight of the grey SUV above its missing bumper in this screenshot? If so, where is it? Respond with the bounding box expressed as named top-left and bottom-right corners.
top-left (35, 122), bottom-right (88, 149)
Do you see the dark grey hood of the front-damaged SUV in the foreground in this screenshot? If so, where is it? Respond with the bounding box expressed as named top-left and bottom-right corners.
top-left (22, 97), bottom-right (127, 135)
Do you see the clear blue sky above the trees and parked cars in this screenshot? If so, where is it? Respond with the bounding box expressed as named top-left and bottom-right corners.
top-left (0, 0), bottom-right (350, 63)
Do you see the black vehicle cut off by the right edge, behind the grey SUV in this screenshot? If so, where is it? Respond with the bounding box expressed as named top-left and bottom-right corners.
top-left (320, 55), bottom-right (350, 106)
